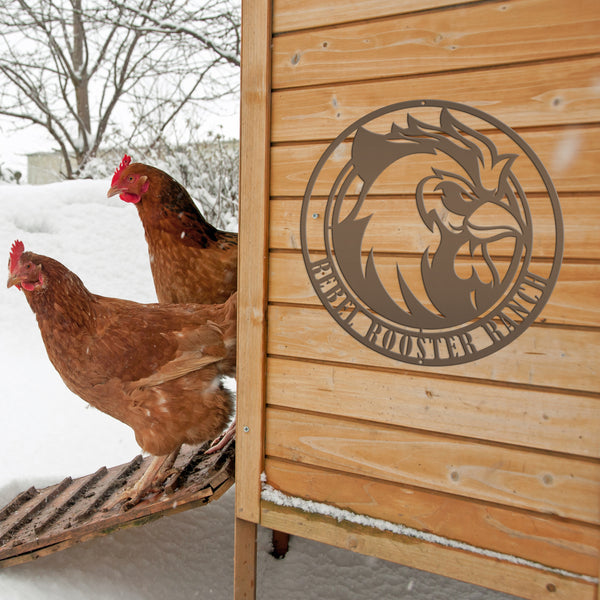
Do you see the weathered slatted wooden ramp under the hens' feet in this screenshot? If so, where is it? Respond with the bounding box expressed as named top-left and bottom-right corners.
top-left (0, 440), bottom-right (235, 568)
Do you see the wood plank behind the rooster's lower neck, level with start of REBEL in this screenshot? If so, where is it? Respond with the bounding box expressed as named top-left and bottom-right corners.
top-left (269, 252), bottom-right (600, 327)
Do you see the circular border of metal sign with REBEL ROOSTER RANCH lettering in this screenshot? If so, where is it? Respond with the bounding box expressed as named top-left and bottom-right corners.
top-left (300, 99), bottom-right (564, 366)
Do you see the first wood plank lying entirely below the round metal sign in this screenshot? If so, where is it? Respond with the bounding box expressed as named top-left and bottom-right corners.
top-left (267, 358), bottom-right (600, 458)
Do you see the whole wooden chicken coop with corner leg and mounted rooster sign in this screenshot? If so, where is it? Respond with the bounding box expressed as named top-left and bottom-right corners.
top-left (235, 0), bottom-right (600, 600)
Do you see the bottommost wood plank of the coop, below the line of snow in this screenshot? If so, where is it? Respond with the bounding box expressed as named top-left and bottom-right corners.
top-left (261, 502), bottom-right (597, 600)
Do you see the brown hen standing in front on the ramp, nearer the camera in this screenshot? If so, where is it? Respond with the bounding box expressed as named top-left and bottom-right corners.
top-left (7, 241), bottom-right (237, 506)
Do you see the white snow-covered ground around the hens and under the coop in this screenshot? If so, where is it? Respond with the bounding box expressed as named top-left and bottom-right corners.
top-left (0, 180), bottom-right (512, 600)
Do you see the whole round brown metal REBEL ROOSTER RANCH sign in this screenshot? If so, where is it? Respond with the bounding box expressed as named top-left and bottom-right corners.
top-left (300, 100), bottom-right (564, 366)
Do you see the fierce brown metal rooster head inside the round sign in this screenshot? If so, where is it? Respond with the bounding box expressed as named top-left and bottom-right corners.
top-left (330, 108), bottom-right (531, 328)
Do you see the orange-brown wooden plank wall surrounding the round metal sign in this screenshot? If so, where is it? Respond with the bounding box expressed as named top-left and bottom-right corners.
top-left (236, 0), bottom-right (600, 600)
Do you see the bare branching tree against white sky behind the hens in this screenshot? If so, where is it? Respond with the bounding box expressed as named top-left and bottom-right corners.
top-left (0, 0), bottom-right (240, 178)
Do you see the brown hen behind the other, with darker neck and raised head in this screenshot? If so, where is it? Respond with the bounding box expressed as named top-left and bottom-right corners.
top-left (108, 155), bottom-right (237, 452)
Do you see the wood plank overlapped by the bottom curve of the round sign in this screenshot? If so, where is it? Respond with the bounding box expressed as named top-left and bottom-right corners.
top-left (268, 305), bottom-right (600, 394)
